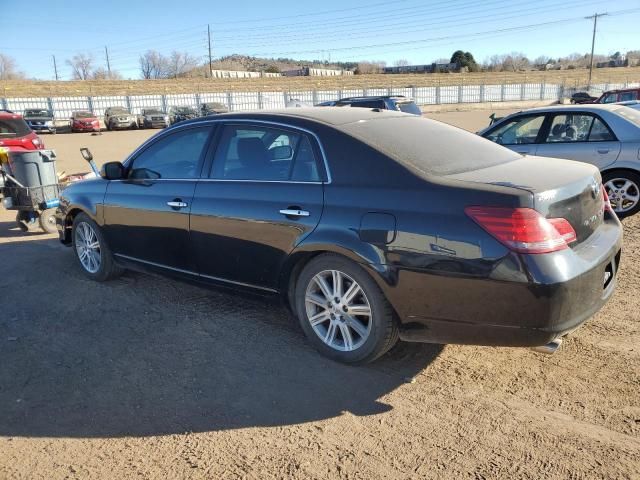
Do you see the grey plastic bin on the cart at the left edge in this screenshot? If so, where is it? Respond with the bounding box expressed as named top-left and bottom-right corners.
top-left (8, 150), bottom-right (58, 187)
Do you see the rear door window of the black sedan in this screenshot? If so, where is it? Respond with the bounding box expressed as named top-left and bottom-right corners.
top-left (211, 125), bottom-right (321, 182)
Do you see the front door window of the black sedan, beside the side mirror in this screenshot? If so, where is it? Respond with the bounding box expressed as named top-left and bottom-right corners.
top-left (129, 127), bottom-right (211, 180)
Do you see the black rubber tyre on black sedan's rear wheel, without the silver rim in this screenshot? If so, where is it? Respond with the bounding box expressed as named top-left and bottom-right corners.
top-left (295, 254), bottom-right (398, 364)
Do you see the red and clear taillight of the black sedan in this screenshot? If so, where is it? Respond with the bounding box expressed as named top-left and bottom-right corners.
top-left (464, 207), bottom-right (577, 253)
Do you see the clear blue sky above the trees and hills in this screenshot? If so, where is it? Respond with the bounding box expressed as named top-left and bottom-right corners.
top-left (0, 0), bottom-right (640, 79)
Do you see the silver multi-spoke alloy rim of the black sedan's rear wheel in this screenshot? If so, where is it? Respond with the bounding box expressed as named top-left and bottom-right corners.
top-left (305, 270), bottom-right (373, 352)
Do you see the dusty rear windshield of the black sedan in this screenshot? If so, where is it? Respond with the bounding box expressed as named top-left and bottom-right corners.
top-left (341, 116), bottom-right (522, 176)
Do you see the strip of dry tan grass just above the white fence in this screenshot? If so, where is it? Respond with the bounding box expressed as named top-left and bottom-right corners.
top-left (0, 67), bottom-right (640, 98)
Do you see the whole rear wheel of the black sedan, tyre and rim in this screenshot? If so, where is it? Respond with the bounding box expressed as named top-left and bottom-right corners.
top-left (295, 254), bottom-right (398, 364)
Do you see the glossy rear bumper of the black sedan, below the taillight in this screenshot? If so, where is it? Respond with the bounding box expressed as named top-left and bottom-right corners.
top-left (372, 219), bottom-right (622, 347)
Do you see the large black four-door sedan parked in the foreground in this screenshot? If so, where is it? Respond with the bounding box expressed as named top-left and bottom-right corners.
top-left (57, 107), bottom-right (622, 363)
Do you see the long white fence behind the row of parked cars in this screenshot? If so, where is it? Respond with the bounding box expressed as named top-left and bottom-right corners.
top-left (0, 83), bottom-right (640, 119)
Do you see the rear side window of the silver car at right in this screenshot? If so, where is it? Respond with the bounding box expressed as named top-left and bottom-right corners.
top-left (546, 113), bottom-right (615, 143)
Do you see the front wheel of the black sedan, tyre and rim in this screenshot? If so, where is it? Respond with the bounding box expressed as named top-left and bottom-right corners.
top-left (71, 213), bottom-right (122, 282)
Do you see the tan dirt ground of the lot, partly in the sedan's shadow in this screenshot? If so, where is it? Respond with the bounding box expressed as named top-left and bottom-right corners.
top-left (0, 112), bottom-right (640, 480)
